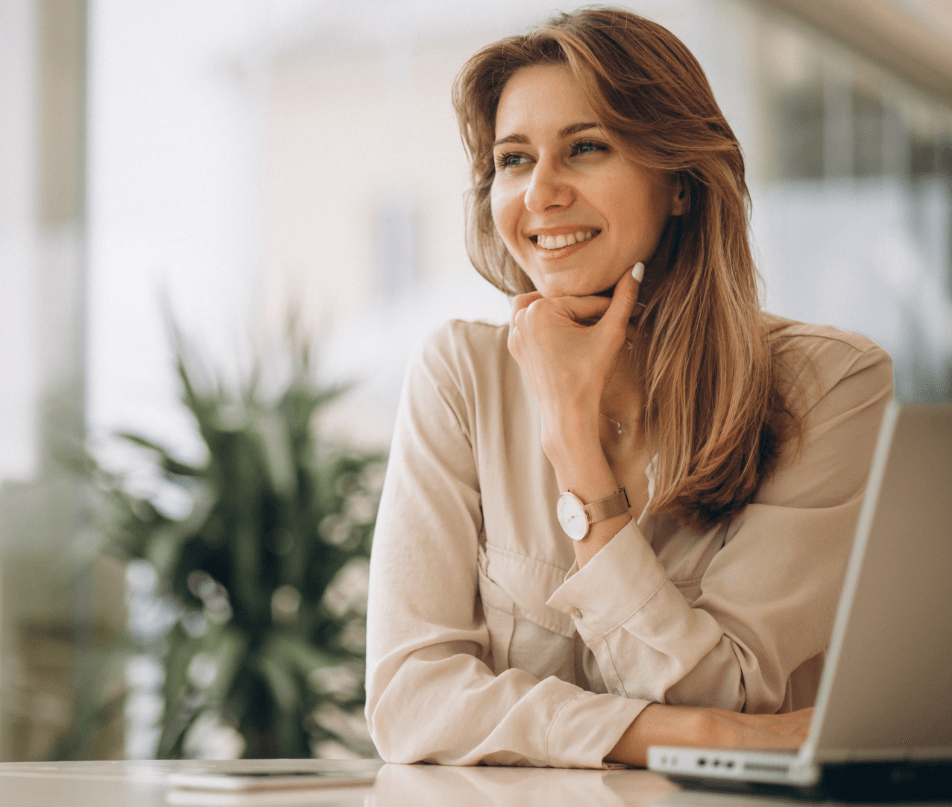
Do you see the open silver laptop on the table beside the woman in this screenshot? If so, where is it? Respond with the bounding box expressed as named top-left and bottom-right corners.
top-left (648, 402), bottom-right (952, 801)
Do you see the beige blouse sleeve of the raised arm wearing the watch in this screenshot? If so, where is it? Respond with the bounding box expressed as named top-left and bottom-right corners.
top-left (548, 338), bottom-right (893, 713)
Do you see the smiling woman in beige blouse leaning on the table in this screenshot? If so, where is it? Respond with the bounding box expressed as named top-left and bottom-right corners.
top-left (367, 9), bottom-right (892, 767)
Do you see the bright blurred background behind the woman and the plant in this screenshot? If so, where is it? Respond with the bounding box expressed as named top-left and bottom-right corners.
top-left (0, 0), bottom-right (952, 760)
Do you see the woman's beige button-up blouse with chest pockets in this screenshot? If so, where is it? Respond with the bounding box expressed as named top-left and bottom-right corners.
top-left (367, 321), bottom-right (893, 767)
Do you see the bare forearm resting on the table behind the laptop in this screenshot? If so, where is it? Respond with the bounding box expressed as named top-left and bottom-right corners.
top-left (605, 703), bottom-right (813, 768)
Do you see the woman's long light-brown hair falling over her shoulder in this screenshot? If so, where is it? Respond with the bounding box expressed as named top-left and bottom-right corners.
top-left (453, 8), bottom-right (802, 531)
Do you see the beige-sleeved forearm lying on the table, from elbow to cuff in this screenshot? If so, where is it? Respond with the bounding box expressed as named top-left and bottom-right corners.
top-left (367, 648), bottom-right (644, 768)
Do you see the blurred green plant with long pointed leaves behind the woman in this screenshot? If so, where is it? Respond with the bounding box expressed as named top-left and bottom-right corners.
top-left (74, 332), bottom-right (383, 757)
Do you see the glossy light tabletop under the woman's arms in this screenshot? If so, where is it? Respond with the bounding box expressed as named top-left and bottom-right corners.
top-left (0, 760), bottom-right (768, 807)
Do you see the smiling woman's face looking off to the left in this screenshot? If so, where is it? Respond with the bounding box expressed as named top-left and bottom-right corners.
top-left (491, 65), bottom-right (683, 297)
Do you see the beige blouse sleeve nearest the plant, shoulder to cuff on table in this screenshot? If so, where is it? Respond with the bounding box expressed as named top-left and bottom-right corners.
top-left (366, 326), bottom-right (646, 768)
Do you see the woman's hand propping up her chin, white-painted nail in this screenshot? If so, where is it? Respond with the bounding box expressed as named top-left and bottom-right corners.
top-left (509, 264), bottom-right (644, 462)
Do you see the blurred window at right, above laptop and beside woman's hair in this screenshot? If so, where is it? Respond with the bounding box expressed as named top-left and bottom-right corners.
top-left (755, 17), bottom-right (952, 400)
